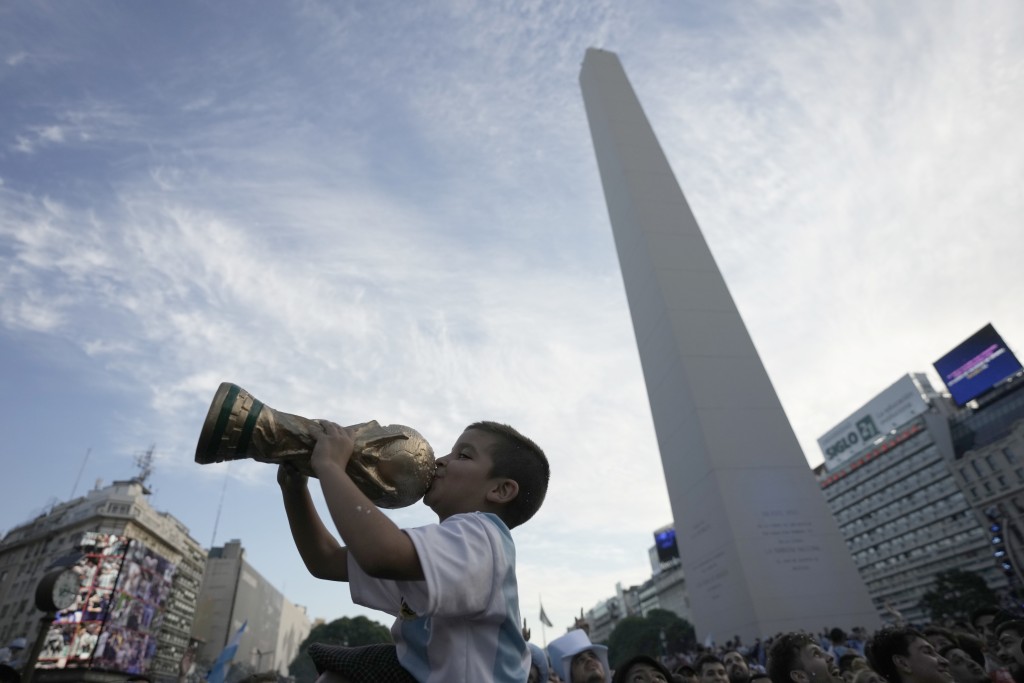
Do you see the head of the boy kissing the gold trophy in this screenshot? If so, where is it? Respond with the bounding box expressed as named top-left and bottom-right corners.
top-left (423, 422), bottom-right (550, 528)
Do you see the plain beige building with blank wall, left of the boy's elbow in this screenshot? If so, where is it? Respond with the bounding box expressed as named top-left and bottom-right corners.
top-left (191, 540), bottom-right (312, 676)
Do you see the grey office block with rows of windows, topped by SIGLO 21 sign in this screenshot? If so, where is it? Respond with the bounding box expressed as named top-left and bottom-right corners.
top-left (818, 374), bottom-right (1007, 627)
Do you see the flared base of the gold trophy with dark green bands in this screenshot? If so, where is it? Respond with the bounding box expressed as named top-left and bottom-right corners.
top-left (196, 382), bottom-right (263, 465)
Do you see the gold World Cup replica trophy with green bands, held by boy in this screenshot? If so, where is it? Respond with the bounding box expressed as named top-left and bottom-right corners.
top-left (196, 382), bottom-right (435, 508)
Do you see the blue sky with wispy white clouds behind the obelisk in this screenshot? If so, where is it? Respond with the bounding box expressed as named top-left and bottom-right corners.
top-left (0, 0), bottom-right (1024, 638)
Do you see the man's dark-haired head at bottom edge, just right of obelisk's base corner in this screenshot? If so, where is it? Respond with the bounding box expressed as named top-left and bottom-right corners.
top-left (867, 628), bottom-right (953, 683)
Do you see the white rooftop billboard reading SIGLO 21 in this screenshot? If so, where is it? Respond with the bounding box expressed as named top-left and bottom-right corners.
top-left (818, 375), bottom-right (928, 472)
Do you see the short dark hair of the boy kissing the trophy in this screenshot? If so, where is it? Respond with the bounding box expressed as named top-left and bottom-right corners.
top-left (466, 420), bottom-right (551, 528)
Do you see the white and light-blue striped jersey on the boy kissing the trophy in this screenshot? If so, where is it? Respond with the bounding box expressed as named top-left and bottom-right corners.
top-left (348, 512), bottom-right (529, 683)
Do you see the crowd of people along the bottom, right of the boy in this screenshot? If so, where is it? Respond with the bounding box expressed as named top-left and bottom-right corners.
top-left (529, 607), bottom-right (1024, 683)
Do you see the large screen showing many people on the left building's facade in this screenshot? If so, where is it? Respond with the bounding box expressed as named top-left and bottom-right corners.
top-left (36, 532), bottom-right (175, 674)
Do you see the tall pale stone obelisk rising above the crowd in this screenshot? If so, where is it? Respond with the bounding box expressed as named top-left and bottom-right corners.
top-left (580, 49), bottom-right (879, 642)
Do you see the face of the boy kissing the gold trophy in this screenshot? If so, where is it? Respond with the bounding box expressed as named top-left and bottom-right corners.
top-left (423, 429), bottom-right (501, 521)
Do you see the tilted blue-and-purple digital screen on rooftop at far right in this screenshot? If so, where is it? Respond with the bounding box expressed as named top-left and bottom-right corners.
top-left (934, 323), bottom-right (1021, 405)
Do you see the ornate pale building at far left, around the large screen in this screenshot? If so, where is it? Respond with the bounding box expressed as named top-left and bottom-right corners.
top-left (0, 476), bottom-right (206, 680)
